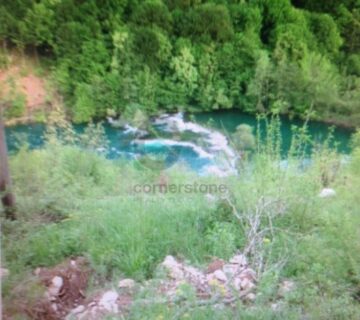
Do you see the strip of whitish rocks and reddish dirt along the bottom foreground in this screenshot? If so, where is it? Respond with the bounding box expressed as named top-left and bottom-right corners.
top-left (5, 254), bottom-right (294, 320)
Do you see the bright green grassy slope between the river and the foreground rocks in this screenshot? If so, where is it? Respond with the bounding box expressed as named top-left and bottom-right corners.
top-left (2, 129), bottom-right (360, 319)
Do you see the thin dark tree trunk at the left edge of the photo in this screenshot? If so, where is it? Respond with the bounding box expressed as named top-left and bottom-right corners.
top-left (0, 109), bottom-right (16, 220)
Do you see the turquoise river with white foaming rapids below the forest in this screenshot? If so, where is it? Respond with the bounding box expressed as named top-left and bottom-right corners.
top-left (6, 110), bottom-right (352, 176)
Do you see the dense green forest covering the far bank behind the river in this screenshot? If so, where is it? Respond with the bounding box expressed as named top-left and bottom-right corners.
top-left (0, 0), bottom-right (360, 126)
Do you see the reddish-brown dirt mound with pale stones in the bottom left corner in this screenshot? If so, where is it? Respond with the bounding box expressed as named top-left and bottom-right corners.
top-left (4, 257), bottom-right (90, 320)
